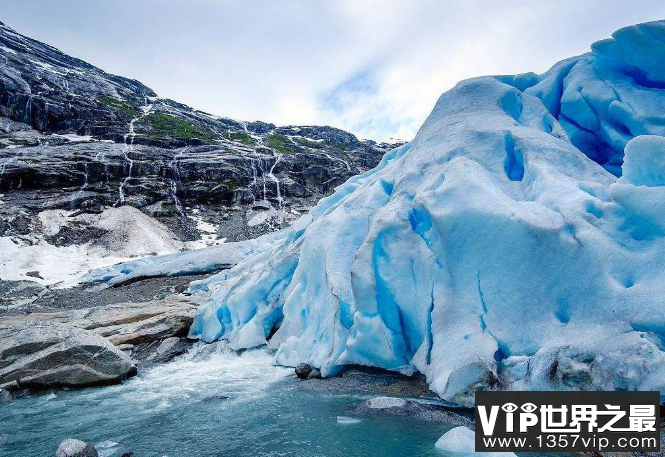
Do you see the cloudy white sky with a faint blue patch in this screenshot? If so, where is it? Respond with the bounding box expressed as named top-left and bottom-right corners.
top-left (0, 0), bottom-right (665, 140)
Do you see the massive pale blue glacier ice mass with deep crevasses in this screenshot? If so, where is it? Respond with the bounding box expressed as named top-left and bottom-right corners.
top-left (185, 22), bottom-right (665, 404)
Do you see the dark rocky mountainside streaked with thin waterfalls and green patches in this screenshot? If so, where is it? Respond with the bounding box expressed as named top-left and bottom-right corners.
top-left (0, 19), bottom-right (400, 284)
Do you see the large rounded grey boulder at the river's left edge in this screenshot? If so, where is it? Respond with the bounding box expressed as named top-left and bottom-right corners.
top-left (0, 323), bottom-right (136, 389)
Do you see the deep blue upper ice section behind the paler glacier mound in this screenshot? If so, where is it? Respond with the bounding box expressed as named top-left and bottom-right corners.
top-left (522, 21), bottom-right (665, 176)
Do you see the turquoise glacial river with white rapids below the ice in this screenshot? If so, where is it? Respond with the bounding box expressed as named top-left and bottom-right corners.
top-left (0, 345), bottom-right (450, 457)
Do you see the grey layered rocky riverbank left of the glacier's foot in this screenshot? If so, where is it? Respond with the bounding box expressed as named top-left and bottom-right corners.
top-left (0, 277), bottom-right (205, 399)
